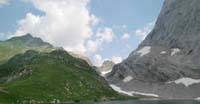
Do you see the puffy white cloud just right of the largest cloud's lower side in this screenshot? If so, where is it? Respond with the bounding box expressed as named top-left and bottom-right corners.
top-left (87, 27), bottom-right (114, 52)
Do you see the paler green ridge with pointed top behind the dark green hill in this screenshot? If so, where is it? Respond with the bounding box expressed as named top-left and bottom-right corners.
top-left (0, 34), bottom-right (54, 64)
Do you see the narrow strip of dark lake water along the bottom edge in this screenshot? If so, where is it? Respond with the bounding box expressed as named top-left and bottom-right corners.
top-left (76, 100), bottom-right (200, 104)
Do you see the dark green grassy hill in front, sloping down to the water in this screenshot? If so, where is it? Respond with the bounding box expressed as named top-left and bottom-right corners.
top-left (0, 50), bottom-right (134, 103)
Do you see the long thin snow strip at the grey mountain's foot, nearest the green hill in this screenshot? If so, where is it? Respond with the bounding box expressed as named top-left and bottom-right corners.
top-left (110, 84), bottom-right (159, 97)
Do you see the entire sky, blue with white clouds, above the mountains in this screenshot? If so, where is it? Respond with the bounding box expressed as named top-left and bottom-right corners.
top-left (0, 0), bottom-right (163, 66)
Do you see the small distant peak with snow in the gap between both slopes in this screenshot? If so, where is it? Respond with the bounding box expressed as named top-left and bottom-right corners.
top-left (97, 60), bottom-right (115, 76)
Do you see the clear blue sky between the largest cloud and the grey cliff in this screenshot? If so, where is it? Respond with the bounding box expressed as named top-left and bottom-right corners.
top-left (91, 0), bottom-right (163, 58)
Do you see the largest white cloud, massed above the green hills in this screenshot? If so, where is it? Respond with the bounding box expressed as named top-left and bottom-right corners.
top-left (10, 0), bottom-right (98, 53)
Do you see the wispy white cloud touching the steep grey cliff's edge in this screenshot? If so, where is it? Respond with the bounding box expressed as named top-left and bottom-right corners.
top-left (135, 22), bottom-right (155, 40)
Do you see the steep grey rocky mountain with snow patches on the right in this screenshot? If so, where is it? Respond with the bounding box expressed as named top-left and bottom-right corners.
top-left (107, 0), bottom-right (200, 99)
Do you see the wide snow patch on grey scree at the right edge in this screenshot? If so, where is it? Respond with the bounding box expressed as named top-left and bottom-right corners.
top-left (168, 78), bottom-right (200, 87)
